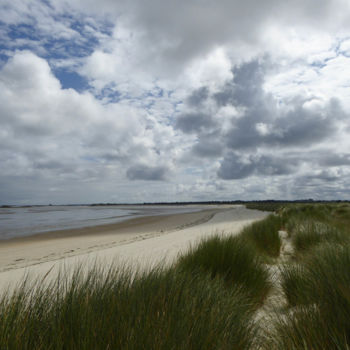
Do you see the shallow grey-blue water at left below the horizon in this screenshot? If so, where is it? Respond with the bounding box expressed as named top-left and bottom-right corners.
top-left (0, 206), bottom-right (203, 240)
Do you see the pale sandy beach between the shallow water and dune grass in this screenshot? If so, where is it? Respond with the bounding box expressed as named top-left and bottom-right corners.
top-left (0, 205), bottom-right (266, 290)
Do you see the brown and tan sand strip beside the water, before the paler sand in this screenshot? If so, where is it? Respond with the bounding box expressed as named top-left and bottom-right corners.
top-left (0, 208), bottom-right (223, 272)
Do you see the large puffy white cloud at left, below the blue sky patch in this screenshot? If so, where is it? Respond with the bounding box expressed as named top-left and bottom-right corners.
top-left (0, 52), bottom-right (171, 183)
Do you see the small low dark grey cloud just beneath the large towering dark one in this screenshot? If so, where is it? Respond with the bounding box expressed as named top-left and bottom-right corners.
top-left (218, 152), bottom-right (298, 180)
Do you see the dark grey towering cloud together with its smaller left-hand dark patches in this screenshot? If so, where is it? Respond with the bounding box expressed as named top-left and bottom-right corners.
top-left (175, 57), bottom-right (347, 165)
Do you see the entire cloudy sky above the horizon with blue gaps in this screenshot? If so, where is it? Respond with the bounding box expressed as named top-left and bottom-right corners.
top-left (0, 0), bottom-right (350, 205)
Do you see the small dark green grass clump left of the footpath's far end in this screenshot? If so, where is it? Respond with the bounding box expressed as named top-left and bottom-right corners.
top-left (242, 214), bottom-right (284, 258)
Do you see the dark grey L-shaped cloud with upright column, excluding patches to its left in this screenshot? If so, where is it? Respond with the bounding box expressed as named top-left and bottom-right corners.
top-left (221, 61), bottom-right (345, 149)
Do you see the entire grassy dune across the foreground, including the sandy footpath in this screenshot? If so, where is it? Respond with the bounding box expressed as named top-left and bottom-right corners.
top-left (0, 203), bottom-right (350, 350)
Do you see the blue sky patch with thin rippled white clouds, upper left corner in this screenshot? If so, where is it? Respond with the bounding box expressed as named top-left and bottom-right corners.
top-left (0, 0), bottom-right (111, 94)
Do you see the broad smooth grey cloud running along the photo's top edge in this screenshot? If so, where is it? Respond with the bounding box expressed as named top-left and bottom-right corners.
top-left (63, 0), bottom-right (350, 77)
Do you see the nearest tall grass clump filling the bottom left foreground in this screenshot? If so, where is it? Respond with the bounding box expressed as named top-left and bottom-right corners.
top-left (0, 268), bottom-right (255, 350)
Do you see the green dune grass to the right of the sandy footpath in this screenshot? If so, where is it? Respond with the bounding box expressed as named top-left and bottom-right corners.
top-left (267, 204), bottom-right (350, 350)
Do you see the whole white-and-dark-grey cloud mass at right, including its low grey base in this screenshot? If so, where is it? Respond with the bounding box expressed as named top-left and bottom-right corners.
top-left (171, 57), bottom-right (348, 190)
